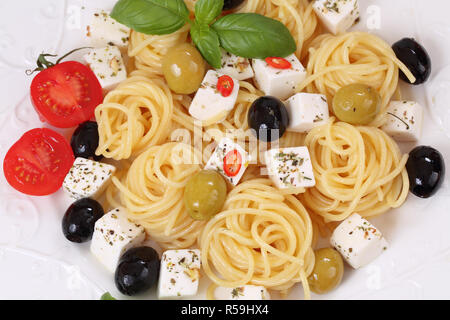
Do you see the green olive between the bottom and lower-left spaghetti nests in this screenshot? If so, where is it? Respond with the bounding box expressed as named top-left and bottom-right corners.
top-left (184, 170), bottom-right (227, 220)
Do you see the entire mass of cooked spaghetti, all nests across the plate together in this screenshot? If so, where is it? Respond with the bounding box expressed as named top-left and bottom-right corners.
top-left (96, 0), bottom-right (414, 298)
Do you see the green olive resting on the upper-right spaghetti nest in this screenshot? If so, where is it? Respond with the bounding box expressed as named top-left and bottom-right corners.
top-left (333, 84), bottom-right (381, 125)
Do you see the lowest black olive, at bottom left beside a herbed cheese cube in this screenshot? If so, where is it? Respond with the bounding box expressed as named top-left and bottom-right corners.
top-left (114, 247), bottom-right (160, 296)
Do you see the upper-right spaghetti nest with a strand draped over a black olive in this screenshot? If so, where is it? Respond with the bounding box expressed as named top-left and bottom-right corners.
top-left (298, 32), bottom-right (415, 127)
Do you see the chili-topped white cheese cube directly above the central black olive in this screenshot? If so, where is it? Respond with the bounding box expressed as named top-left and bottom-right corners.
top-left (252, 54), bottom-right (306, 100)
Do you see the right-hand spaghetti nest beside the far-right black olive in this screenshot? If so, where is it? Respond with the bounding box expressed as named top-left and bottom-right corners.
top-left (299, 118), bottom-right (409, 222)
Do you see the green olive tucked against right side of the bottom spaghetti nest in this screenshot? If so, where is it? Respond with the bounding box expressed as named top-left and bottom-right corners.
top-left (308, 248), bottom-right (344, 294)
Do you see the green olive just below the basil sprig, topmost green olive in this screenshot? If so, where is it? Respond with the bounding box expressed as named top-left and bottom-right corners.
top-left (163, 43), bottom-right (206, 94)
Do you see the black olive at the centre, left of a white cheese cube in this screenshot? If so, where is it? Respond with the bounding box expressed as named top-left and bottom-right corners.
top-left (248, 96), bottom-right (289, 142)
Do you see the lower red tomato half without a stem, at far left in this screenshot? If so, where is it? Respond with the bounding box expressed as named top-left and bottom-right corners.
top-left (3, 128), bottom-right (75, 196)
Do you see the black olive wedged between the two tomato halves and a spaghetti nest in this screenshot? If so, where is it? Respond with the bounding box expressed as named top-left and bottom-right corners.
top-left (70, 121), bottom-right (103, 161)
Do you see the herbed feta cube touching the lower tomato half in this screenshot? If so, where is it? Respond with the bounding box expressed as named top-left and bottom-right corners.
top-left (63, 158), bottom-right (116, 200)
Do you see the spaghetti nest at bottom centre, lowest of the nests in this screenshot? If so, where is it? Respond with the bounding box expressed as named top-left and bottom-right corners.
top-left (200, 179), bottom-right (314, 298)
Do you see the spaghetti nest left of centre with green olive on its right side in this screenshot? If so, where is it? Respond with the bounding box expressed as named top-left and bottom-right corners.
top-left (113, 142), bottom-right (204, 248)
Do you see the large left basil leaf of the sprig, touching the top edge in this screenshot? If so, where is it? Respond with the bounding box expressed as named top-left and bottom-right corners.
top-left (111, 0), bottom-right (189, 35)
